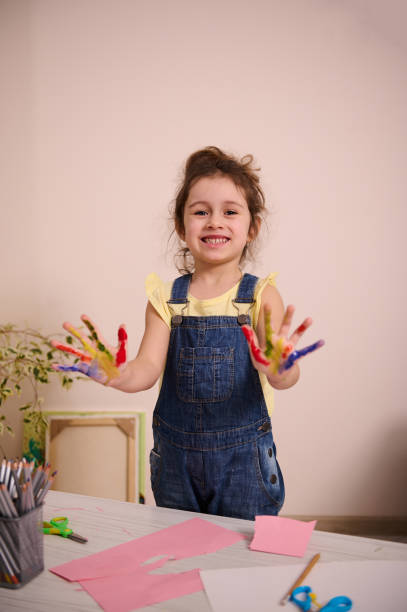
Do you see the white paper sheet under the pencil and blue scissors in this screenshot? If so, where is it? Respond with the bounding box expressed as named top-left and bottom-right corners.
top-left (200, 560), bottom-right (407, 612)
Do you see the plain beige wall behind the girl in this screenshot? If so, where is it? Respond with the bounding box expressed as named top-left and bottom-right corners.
top-left (0, 0), bottom-right (407, 515)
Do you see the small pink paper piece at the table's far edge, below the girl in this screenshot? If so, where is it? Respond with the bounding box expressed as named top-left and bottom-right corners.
top-left (249, 516), bottom-right (316, 557)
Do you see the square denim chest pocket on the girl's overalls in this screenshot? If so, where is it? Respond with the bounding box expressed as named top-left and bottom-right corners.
top-left (177, 346), bottom-right (234, 403)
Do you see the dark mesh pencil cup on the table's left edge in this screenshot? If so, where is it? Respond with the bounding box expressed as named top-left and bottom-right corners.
top-left (0, 505), bottom-right (44, 589)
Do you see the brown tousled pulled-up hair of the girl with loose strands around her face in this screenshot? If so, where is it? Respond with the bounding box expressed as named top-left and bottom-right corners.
top-left (172, 146), bottom-right (266, 274)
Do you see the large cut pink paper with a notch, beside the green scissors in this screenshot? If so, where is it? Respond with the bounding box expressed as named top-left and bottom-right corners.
top-left (50, 518), bottom-right (245, 612)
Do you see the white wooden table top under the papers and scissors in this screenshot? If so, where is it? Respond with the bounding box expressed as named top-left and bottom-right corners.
top-left (0, 491), bottom-right (407, 612)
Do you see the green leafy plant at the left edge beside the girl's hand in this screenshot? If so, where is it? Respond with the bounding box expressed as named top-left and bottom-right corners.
top-left (0, 323), bottom-right (78, 434)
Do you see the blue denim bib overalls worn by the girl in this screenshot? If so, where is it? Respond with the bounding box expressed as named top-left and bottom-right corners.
top-left (150, 274), bottom-right (284, 520)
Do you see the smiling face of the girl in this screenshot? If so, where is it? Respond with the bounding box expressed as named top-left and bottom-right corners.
top-left (180, 174), bottom-right (256, 265)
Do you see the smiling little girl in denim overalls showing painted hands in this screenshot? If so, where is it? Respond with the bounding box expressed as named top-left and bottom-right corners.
top-left (54, 147), bottom-right (322, 520)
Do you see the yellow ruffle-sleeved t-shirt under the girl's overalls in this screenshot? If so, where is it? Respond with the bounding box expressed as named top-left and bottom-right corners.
top-left (146, 273), bottom-right (276, 416)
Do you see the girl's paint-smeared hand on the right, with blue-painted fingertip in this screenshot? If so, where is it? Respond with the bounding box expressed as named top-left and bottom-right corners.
top-left (242, 306), bottom-right (325, 385)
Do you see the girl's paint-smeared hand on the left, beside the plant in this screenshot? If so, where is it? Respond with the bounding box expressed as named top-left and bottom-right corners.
top-left (51, 315), bottom-right (127, 386)
